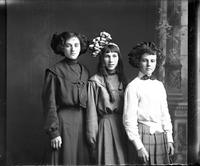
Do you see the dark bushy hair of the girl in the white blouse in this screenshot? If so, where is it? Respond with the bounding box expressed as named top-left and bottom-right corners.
top-left (128, 42), bottom-right (165, 71)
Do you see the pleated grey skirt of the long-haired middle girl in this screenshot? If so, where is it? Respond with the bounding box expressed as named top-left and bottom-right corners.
top-left (98, 114), bottom-right (128, 165)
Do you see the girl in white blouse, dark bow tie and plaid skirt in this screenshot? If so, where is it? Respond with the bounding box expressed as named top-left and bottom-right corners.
top-left (123, 42), bottom-right (174, 164)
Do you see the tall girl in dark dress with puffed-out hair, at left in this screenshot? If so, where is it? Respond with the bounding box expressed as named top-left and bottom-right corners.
top-left (42, 32), bottom-right (89, 165)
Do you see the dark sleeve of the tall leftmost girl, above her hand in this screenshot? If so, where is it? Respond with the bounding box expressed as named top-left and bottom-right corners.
top-left (42, 69), bottom-right (60, 139)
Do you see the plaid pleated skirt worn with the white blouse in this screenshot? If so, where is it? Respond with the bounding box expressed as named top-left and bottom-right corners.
top-left (129, 123), bottom-right (170, 165)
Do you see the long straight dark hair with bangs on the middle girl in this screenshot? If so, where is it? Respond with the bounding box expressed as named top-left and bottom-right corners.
top-left (98, 43), bottom-right (127, 102)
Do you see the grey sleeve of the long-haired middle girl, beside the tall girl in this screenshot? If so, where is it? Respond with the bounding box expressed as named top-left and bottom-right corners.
top-left (86, 81), bottom-right (98, 145)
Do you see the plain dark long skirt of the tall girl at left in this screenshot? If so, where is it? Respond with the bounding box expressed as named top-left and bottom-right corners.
top-left (44, 108), bottom-right (90, 165)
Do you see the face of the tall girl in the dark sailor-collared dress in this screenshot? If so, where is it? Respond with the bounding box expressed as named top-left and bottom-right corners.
top-left (64, 37), bottom-right (81, 60)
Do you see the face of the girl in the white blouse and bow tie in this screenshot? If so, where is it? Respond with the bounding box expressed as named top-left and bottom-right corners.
top-left (140, 53), bottom-right (157, 76)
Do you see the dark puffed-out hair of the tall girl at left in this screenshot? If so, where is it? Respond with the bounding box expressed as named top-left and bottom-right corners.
top-left (51, 32), bottom-right (89, 56)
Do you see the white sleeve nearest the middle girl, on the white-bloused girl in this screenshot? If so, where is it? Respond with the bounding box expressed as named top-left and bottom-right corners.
top-left (123, 83), bottom-right (144, 150)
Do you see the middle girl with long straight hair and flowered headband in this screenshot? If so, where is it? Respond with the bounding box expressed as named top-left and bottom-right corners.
top-left (86, 32), bottom-right (128, 165)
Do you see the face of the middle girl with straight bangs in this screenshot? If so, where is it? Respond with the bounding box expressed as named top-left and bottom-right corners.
top-left (104, 52), bottom-right (119, 71)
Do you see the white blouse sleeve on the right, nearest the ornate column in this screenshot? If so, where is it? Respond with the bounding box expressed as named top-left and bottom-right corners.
top-left (161, 83), bottom-right (173, 142)
